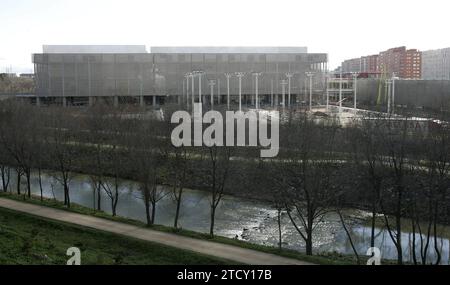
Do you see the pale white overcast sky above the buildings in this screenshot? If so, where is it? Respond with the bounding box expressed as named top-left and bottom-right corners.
top-left (0, 0), bottom-right (450, 72)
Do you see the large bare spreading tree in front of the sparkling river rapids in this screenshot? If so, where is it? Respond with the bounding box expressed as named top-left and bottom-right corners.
top-left (273, 114), bottom-right (338, 255)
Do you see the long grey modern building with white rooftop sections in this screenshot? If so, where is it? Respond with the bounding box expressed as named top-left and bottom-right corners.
top-left (33, 46), bottom-right (327, 105)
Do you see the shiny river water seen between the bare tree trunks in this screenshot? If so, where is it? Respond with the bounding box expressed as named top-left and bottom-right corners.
top-left (0, 170), bottom-right (450, 264)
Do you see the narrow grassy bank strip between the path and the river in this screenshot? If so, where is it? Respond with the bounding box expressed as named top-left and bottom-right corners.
top-left (0, 193), bottom-right (364, 265)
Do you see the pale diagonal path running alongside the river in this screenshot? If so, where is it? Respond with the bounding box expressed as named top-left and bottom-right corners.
top-left (0, 198), bottom-right (310, 265)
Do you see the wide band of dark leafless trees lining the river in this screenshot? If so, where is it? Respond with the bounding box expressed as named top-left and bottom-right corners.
top-left (0, 101), bottom-right (450, 264)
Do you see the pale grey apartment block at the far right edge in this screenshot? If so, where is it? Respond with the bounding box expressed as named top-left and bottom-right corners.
top-left (422, 48), bottom-right (450, 80)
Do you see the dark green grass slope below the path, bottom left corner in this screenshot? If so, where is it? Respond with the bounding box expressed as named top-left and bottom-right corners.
top-left (0, 205), bottom-right (236, 265)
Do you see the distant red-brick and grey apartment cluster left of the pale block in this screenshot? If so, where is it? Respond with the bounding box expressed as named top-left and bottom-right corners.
top-left (342, 47), bottom-right (422, 79)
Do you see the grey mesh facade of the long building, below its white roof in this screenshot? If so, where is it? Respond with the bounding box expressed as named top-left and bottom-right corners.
top-left (33, 53), bottom-right (327, 100)
